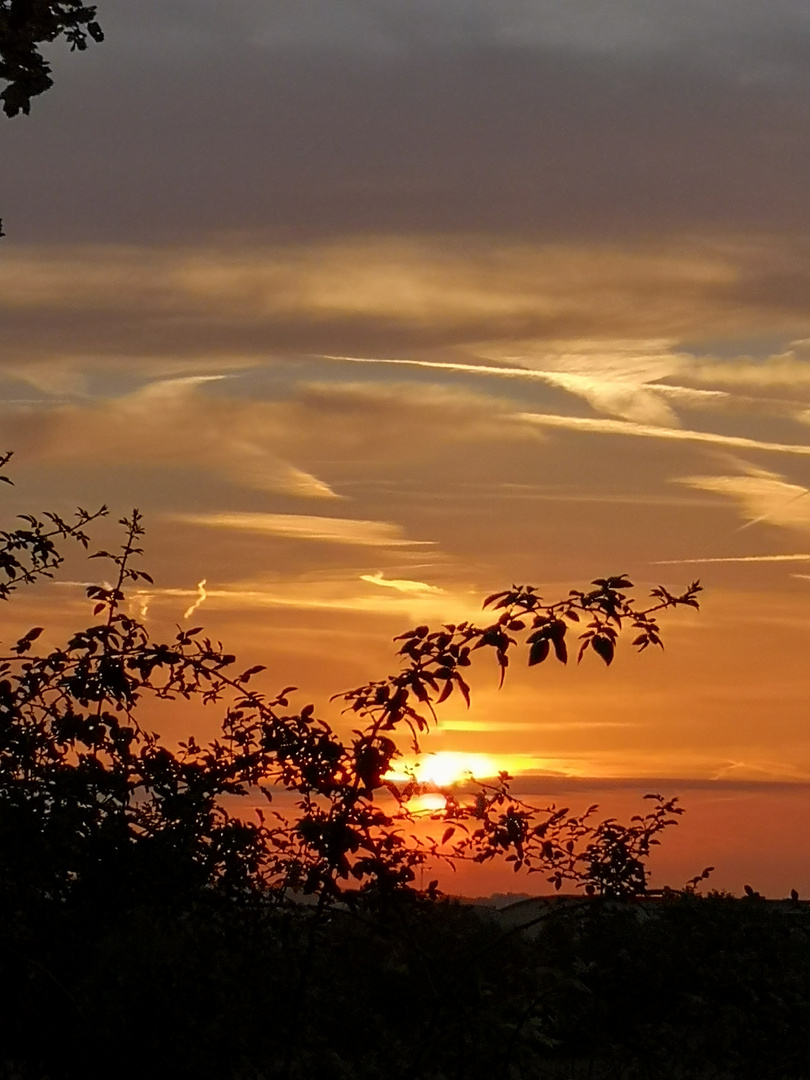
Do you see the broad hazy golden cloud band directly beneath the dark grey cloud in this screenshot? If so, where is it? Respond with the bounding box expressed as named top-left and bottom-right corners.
top-left (0, 237), bottom-right (737, 325)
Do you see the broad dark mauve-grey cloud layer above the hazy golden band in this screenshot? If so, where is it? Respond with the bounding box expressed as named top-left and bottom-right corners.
top-left (0, 18), bottom-right (810, 241)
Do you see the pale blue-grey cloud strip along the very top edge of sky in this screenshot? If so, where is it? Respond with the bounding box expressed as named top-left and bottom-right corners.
top-left (96, 0), bottom-right (810, 66)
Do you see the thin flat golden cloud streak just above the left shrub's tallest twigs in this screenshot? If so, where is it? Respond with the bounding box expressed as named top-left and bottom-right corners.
top-left (172, 511), bottom-right (432, 548)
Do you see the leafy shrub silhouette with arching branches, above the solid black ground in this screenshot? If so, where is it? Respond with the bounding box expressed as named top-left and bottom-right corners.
top-left (0, 456), bottom-right (700, 907)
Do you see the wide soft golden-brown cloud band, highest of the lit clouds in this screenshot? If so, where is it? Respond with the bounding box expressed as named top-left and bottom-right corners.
top-left (0, 234), bottom-right (756, 352)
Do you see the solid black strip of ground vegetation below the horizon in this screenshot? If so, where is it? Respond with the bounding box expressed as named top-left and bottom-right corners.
top-left (2, 895), bottom-right (810, 1080)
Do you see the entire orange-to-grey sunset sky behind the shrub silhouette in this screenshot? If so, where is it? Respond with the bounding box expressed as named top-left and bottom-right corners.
top-left (0, 0), bottom-right (810, 895)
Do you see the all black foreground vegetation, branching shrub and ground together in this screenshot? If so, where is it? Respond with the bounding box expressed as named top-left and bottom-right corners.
top-left (0, 458), bottom-right (810, 1080)
